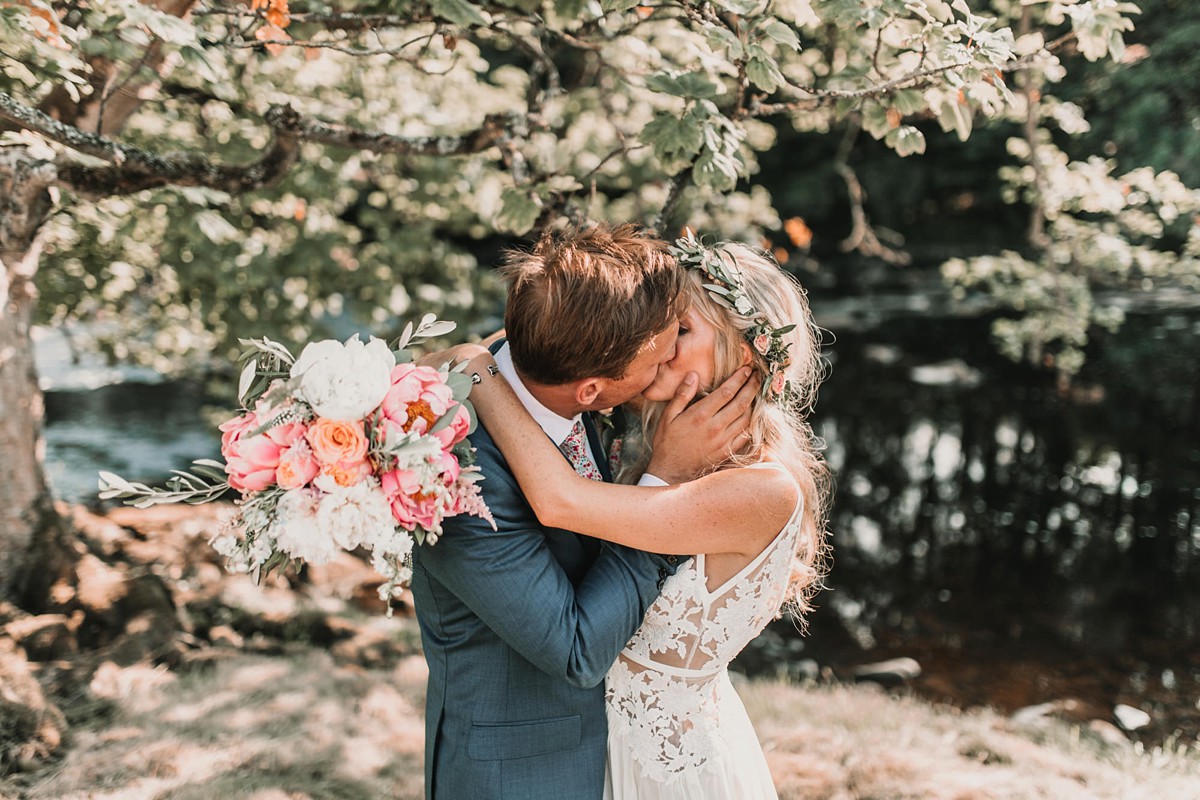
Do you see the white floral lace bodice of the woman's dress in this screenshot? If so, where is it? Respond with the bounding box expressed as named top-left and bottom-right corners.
top-left (605, 462), bottom-right (802, 783)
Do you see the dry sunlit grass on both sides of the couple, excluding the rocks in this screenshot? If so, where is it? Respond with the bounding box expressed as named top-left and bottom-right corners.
top-left (0, 650), bottom-right (1200, 800)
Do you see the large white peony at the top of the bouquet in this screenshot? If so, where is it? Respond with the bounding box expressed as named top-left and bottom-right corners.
top-left (292, 333), bottom-right (396, 420)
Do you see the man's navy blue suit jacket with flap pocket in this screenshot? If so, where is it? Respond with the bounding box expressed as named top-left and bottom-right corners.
top-left (412, 376), bottom-right (676, 800)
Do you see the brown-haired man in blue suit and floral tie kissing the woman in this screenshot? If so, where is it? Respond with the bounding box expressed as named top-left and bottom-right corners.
top-left (412, 225), bottom-right (729, 800)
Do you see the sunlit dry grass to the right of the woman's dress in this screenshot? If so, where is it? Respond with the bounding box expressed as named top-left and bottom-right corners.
top-left (739, 682), bottom-right (1200, 800)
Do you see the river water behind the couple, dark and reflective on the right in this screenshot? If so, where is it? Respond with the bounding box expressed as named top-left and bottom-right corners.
top-left (42, 297), bottom-right (1200, 742)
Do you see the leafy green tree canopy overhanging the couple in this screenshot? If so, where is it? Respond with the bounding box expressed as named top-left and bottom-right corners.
top-left (0, 0), bottom-right (1200, 372)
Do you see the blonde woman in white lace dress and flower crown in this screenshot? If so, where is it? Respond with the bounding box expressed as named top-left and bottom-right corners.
top-left (448, 237), bottom-right (828, 800)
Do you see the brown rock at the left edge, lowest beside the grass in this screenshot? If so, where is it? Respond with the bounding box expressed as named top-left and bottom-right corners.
top-left (0, 638), bottom-right (67, 775)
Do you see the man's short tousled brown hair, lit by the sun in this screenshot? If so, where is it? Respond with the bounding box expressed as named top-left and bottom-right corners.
top-left (500, 224), bottom-right (685, 385)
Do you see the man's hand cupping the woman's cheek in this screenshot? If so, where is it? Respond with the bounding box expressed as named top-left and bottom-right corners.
top-left (646, 367), bottom-right (760, 483)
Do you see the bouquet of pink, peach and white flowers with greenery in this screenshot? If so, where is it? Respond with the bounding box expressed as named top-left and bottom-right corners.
top-left (100, 314), bottom-right (494, 600)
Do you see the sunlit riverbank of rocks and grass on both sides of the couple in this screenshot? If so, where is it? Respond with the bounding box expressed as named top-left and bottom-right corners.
top-left (0, 506), bottom-right (1200, 800)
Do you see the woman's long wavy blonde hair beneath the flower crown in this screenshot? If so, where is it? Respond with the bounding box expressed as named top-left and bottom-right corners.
top-left (620, 242), bottom-right (832, 621)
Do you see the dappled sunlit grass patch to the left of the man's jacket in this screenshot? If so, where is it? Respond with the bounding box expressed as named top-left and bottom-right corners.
top-left (29, 650), bottom-right (424, 800)
